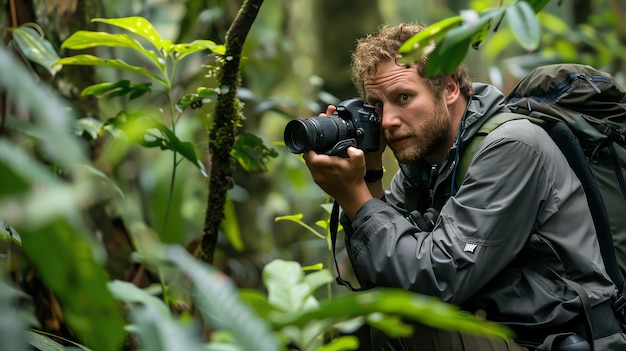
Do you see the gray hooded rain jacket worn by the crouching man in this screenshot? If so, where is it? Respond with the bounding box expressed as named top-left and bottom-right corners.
top-left (342, 84), bottom-right (626, 350)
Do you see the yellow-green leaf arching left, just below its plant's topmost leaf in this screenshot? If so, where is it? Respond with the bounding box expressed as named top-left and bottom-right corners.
top-left (61, 30), bottom-right (164, 69)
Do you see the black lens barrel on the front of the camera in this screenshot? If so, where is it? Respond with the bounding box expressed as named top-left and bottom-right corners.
top-left (285, 116), bottom-right (349, 154)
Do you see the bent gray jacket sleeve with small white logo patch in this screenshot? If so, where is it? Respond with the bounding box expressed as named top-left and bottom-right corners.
top-left (344, 121), bottom-right (566, 304)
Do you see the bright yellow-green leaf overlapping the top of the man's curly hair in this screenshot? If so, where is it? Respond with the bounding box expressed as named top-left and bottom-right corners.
top-left (398, 16), bottom-right (463, 64)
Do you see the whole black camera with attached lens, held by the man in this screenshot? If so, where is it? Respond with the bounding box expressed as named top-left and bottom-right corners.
top-left (284, 98), bottom-right (380, 155)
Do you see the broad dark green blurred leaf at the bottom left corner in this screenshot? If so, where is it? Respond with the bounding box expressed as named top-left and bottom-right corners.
top-left (18, 218), bottom-right (124, 351)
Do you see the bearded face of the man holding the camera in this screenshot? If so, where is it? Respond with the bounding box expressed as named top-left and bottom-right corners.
top-left (364, 60), bottom-right (451, 164)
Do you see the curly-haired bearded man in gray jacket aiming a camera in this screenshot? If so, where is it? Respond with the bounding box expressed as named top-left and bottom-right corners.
top-left (304, 25), bottom-right (626, 351)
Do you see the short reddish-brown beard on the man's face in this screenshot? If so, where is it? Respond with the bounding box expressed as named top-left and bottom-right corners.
top-left (385, 100), bottom-right (450, 163)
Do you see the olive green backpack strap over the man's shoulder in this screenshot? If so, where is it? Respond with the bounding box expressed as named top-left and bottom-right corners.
top-left (455, 112), bottom-right (528, 189)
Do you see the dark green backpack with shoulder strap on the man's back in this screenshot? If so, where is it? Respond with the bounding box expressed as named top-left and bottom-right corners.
top-left (456, 64), bottom-right (626, 350)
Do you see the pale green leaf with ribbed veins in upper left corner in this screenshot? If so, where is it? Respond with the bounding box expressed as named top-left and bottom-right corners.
top-left (13, 26), bottom-right (61, 76)
